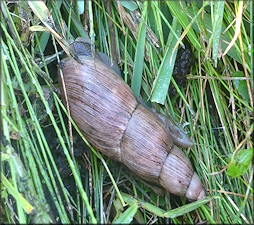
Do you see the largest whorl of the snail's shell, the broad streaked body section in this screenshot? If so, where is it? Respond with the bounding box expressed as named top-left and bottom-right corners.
top-left (62, 56), bottom-right (138, 161)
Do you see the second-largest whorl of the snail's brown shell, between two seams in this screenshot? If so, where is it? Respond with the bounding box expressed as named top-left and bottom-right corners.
top-left (121, 104), bottom-right (173, 184)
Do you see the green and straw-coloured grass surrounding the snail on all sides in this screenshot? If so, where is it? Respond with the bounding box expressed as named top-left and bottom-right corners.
top-left (1, 0), bottom-right (254, 224)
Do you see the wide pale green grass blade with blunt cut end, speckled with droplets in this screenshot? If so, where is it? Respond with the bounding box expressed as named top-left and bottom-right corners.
top-left (151, 18), bottom-right (182, 104)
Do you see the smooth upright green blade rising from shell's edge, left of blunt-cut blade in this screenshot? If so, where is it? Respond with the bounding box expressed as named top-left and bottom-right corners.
top-left (131, 2), bottom-right (148, 97)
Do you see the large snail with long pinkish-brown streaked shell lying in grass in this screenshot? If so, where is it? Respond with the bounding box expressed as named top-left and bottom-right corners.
top-left (60, 38), bottom-right (205, 201)
